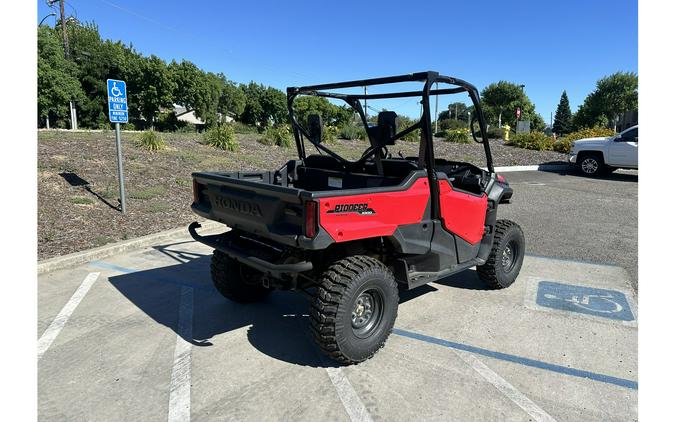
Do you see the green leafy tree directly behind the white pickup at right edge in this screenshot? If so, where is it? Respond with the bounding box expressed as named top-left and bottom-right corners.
top-left (573, 72), bottom-right (638, 130)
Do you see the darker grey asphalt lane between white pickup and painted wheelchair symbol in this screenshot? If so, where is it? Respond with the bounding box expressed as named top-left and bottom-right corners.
top-left (499, 170), bottom-right (638, 290)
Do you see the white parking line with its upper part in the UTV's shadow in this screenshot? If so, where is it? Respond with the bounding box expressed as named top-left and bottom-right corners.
top-left (168, 286), bottom-right (194, 422)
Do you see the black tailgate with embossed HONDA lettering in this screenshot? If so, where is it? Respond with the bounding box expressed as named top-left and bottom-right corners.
top-left (192, 172), bottom-right (304, 246)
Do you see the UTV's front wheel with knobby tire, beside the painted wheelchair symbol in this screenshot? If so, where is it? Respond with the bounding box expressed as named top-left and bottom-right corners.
top-left (476, 220), bottom-right (525, 289)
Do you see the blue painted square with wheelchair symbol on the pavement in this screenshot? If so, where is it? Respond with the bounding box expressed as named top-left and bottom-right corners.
top-left (537, 281), bottom-right (635, 321)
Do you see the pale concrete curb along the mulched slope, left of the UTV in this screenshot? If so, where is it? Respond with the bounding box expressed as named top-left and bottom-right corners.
top-left (37, 221), bottom-right (226, 274)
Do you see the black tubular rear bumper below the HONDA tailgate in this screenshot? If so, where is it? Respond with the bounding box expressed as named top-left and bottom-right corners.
top-left (188, 221), bottom-right (313, 278)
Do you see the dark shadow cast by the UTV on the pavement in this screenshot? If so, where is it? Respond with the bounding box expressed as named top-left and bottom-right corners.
top-left (109, 256), bottom-right (337, 367)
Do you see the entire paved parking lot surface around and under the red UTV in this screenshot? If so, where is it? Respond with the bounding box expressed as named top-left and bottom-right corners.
top-left (37, 172), bottom-right (638, 421)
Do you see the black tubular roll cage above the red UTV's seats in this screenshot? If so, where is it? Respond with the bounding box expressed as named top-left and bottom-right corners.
top-left (286, 71), bottom-right (494, 173)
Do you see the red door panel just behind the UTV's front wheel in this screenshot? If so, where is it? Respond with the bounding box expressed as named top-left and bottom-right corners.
top-left (438, 180), bottom-right (487, 244)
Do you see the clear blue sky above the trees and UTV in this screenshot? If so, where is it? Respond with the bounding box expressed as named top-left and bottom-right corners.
top-left (37, 0), bottom-right (638, 123)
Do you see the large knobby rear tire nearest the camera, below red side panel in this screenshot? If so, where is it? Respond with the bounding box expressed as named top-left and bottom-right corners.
top-left (310, 255), bottom-right (398, 364)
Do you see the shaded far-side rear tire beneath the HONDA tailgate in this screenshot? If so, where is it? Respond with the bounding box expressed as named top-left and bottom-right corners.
top-left (211, 250), bottom-right (271, 303)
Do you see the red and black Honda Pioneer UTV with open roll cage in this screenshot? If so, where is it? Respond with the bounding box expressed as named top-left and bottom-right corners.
top-left (189, 71), bottom-right (525, 364)
